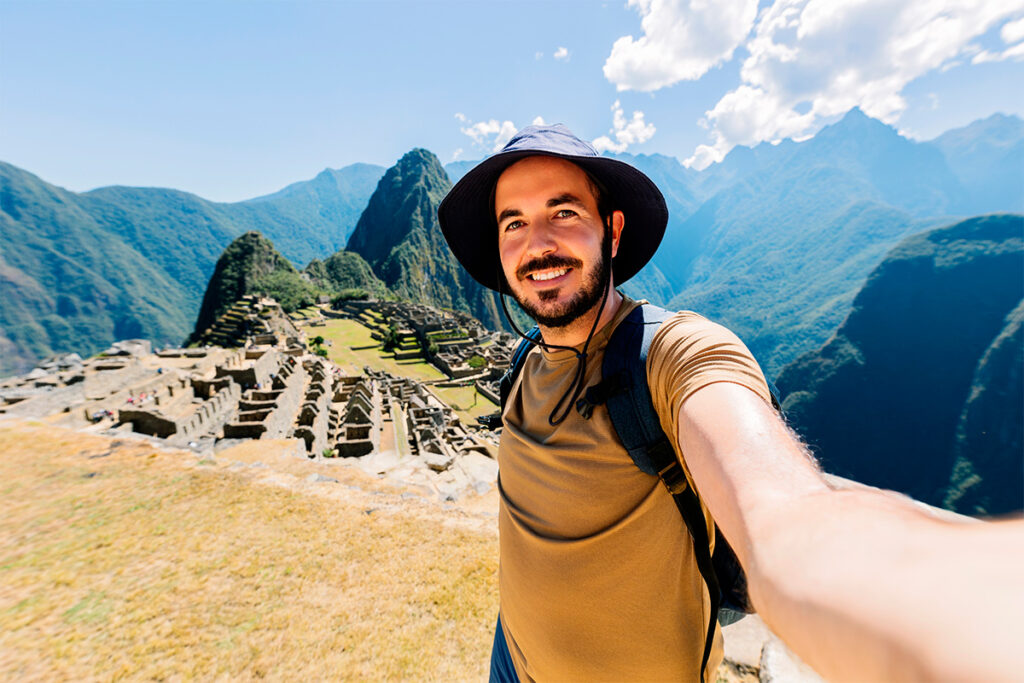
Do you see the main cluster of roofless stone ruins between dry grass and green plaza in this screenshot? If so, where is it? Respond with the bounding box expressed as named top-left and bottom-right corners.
top-left (0, 298), bottom-right (495, 489)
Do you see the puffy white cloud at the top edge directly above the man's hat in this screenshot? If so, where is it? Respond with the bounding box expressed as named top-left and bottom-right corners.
top-left (604, 0), bottom-right (758, 91)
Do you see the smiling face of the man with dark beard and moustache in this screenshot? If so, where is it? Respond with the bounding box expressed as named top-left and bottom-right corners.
top-left (495, 157), bottom-right (623, 328)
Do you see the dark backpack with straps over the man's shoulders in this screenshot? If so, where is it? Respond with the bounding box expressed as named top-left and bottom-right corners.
top-left (481, 303), bottom-right (780, 680)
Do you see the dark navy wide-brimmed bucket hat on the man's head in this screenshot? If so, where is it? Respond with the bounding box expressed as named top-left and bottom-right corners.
top-left (437, 124), bottom-right (669, 292)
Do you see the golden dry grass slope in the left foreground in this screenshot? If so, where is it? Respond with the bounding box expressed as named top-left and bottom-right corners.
top-left (0, 422), bottom-right (498, 680)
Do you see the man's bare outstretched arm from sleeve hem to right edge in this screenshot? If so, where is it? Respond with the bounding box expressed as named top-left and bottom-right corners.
top-left (678, 382), bottom-right (1024, 680)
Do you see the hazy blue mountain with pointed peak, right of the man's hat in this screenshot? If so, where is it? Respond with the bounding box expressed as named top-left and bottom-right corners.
top-left (657, 110), bottom-right (964, 375)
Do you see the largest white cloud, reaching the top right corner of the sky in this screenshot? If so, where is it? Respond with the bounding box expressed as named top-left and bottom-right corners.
top-left (675, 0), bottom-right (1024, 168)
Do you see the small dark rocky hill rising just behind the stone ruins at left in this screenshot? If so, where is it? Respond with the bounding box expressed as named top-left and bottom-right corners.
top-left (191, 230), bottom-right (317, 340)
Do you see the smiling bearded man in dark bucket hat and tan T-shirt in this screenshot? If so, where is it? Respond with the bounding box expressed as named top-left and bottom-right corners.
top-left (438, 126), bottom-right (1022, 681)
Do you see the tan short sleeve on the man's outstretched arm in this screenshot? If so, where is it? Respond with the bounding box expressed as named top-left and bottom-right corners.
top-left (647, 311), bottom-right (771, 493)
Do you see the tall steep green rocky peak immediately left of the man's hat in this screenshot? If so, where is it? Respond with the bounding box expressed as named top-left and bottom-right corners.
top-left (348, 150), bottom-right (502, 329)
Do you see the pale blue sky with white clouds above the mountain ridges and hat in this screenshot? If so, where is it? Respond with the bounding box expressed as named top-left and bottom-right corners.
top-left (0, 0), bottom-right (1024, 202)
